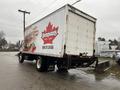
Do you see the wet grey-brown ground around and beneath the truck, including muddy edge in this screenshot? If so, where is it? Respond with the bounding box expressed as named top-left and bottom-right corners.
top-left (0, 52), bottom-right (120, 90)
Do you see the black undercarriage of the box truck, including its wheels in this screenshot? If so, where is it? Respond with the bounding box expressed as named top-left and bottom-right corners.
top-left (18, 52), bottom-right (98, 72)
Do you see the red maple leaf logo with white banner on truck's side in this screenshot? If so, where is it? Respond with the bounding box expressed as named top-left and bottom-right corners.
top-left (41, 22), bottom-right (58, 44)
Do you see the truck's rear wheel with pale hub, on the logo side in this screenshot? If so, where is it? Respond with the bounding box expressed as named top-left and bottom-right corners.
top-left (36, 57), bottom-right (48, 72)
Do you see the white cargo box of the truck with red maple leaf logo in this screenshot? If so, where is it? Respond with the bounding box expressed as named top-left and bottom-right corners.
top-left (22, 5), bottom-right (96, 57)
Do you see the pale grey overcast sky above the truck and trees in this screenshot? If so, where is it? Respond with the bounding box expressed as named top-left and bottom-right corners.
top-left (0, 0), bottom-right (120, 42)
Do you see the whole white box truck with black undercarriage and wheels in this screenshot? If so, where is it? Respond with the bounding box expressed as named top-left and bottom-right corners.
top-left (19, 4), bottom-right (98, 72)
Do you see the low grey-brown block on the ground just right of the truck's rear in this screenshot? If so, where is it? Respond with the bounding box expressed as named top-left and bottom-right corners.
top-left (95, 60), bottom-right (110, 73)
